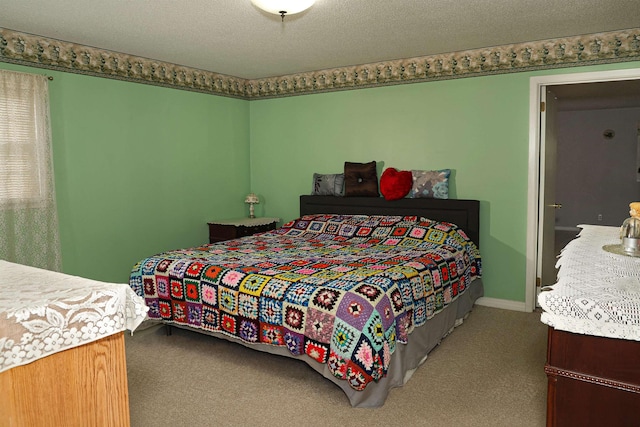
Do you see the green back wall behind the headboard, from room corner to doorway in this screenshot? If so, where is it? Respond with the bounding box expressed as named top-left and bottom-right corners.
top-left (250, 62), bottom-right (640, 302)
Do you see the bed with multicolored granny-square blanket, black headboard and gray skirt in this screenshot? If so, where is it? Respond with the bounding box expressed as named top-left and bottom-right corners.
top-left (130, 196), bottom-right (483, 407)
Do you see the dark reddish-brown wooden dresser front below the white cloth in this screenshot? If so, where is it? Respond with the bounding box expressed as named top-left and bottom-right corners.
top-left (544, 327), bottom-right (640, 427)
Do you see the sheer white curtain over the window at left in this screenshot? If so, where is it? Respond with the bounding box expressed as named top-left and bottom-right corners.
top-left (0, 70), bottom-right (62, 271)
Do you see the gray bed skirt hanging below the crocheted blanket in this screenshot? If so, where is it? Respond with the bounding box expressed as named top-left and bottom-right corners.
top-left (158, 279), bottom-right (484, 408)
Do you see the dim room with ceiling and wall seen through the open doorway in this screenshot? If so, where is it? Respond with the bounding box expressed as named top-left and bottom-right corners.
top-left (542, 79), bottom-right (640, 256)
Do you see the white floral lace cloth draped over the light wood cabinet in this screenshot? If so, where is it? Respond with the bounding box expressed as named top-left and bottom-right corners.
top-left (0, 260), bottom-right (148, 372)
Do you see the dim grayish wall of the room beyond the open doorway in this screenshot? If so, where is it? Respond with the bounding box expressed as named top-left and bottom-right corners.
top-left (556, 108), bottom-right (640, 228)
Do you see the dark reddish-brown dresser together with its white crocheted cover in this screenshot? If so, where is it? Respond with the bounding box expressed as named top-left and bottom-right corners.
top-left (538, 226), bottom-right (640, 427)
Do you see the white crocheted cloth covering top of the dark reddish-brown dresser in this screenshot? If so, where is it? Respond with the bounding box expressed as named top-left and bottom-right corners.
top-left (538, 225), bottom-right (640, 341)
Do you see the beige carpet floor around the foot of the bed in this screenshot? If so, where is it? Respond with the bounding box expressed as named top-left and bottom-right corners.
top-left (126, 306), bottom-right (546, 427)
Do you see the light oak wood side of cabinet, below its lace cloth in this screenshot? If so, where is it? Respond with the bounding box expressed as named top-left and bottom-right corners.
top-left (0, 332), bottom-right (130, 427)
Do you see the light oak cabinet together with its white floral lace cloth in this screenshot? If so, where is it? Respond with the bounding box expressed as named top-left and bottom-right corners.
top-left (0, 260), bottom-right (148, 427)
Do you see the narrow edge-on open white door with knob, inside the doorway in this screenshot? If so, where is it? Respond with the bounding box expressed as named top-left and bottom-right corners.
top-left (536, 86), bottom-right (561, 292)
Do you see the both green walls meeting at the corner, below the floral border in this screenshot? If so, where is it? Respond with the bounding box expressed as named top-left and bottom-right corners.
top-left (0, 58), bottom-right (640, 302)
